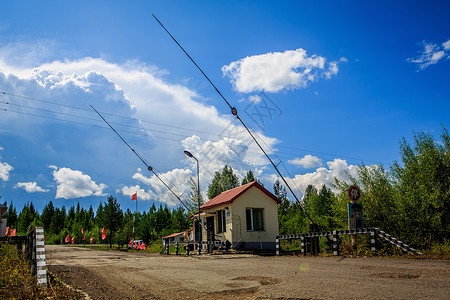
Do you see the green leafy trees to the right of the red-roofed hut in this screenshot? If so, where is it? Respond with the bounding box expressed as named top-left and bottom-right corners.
top-left (274, 127), bottom-right (450, 249)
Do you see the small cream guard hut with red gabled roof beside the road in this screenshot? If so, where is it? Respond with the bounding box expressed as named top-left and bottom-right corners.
top-left (200, 181), bottom-right (281, 250)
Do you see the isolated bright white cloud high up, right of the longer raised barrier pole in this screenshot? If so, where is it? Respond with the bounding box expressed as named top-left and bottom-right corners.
top-left (222, 48), bottom-right (338, 93)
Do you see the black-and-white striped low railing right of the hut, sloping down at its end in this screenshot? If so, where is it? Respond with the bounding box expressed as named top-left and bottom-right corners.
top-left (276, 228), bottom-right (422, 256)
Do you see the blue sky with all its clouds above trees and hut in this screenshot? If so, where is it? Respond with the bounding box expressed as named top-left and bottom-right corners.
top-left (0, 0), bottom-right (450, 211)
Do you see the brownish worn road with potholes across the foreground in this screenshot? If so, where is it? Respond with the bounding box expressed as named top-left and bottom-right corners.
top-left (45, 245), bottom-right (450, 299)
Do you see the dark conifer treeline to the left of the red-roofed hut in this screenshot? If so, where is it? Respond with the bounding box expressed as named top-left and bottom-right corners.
top-left (5, 196), bottom-right (190, 245)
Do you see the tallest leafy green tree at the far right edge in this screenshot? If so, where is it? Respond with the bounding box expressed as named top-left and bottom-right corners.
top-left (392, 126), bottom-right (450, 246)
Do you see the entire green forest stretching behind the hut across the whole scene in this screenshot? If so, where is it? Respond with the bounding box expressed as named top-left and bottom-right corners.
top-left (1, 126), bottom-right (450, 249)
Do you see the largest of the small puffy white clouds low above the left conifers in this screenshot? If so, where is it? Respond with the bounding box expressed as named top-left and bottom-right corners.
top-left (52, 166), bottom-right (108, 199)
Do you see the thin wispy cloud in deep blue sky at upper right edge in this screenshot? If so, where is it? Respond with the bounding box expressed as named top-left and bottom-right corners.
top-left (407, 40), bottom-right (450, 71)
